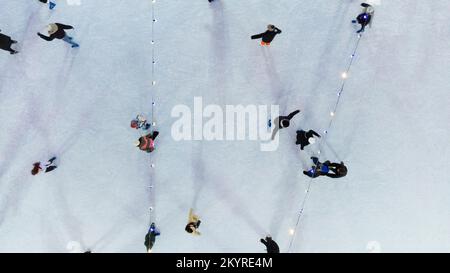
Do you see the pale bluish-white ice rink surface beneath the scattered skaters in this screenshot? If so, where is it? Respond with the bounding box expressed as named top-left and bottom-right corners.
top-left (0, 0), bottom-right (450, 253)
